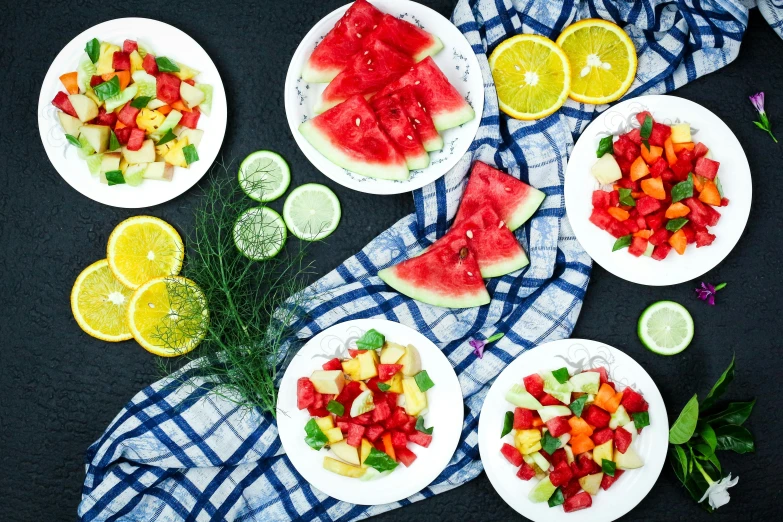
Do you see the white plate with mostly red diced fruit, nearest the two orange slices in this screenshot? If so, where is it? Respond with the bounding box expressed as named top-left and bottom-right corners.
top-left (565, 96), bottom-right (752, 286)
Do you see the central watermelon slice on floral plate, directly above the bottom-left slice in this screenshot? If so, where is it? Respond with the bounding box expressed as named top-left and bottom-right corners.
top-left (315, 40), bottom-right (413, 114)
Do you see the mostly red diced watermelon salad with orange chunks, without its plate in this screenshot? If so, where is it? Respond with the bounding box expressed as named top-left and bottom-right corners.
top-left (590, 111), bottom-right (729, 261)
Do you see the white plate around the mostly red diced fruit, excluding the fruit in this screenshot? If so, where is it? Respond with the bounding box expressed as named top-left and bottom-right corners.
top-left (565, 96), bottom-right (752, 286)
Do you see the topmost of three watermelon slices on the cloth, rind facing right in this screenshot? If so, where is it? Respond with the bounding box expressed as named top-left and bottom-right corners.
top-left (453, 161), bottom-right (545, 231)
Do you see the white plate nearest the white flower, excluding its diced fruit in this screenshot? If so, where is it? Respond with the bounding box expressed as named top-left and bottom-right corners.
top-left (479, 339), bottom-right (669, 522)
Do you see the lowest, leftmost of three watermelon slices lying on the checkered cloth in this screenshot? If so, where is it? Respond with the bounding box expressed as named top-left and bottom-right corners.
top-left (378, 237), bottom-right (489, 308)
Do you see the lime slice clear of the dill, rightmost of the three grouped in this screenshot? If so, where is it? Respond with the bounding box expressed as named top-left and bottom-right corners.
top-left (283, 183), bottom-right (342, 241)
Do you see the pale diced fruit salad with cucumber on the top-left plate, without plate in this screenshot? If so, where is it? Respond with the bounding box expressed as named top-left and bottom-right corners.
top-left (52, 38), bottom-right (212, 186)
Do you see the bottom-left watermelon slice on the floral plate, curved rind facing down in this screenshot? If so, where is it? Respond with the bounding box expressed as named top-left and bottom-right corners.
top-left (299, 95), bottom-right (409, 180)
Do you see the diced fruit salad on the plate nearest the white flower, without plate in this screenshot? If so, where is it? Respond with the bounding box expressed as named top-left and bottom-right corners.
top-left (500, 367), bottom-right (650, 513)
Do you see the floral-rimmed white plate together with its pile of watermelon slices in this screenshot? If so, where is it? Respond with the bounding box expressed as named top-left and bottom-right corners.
top-left (285, 0), bottom-right (484, 194)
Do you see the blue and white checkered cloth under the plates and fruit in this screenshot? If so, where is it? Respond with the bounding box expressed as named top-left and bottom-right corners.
top-left (79, 0), bottom-right (764, 522)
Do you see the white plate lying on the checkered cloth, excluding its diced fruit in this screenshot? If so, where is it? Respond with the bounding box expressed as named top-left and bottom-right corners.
top-left (277, 319), bottom-right (464, 506)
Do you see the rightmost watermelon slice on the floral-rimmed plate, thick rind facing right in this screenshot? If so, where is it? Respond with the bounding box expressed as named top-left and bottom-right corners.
top-left (376, 57), bottom-right (476, 130)
